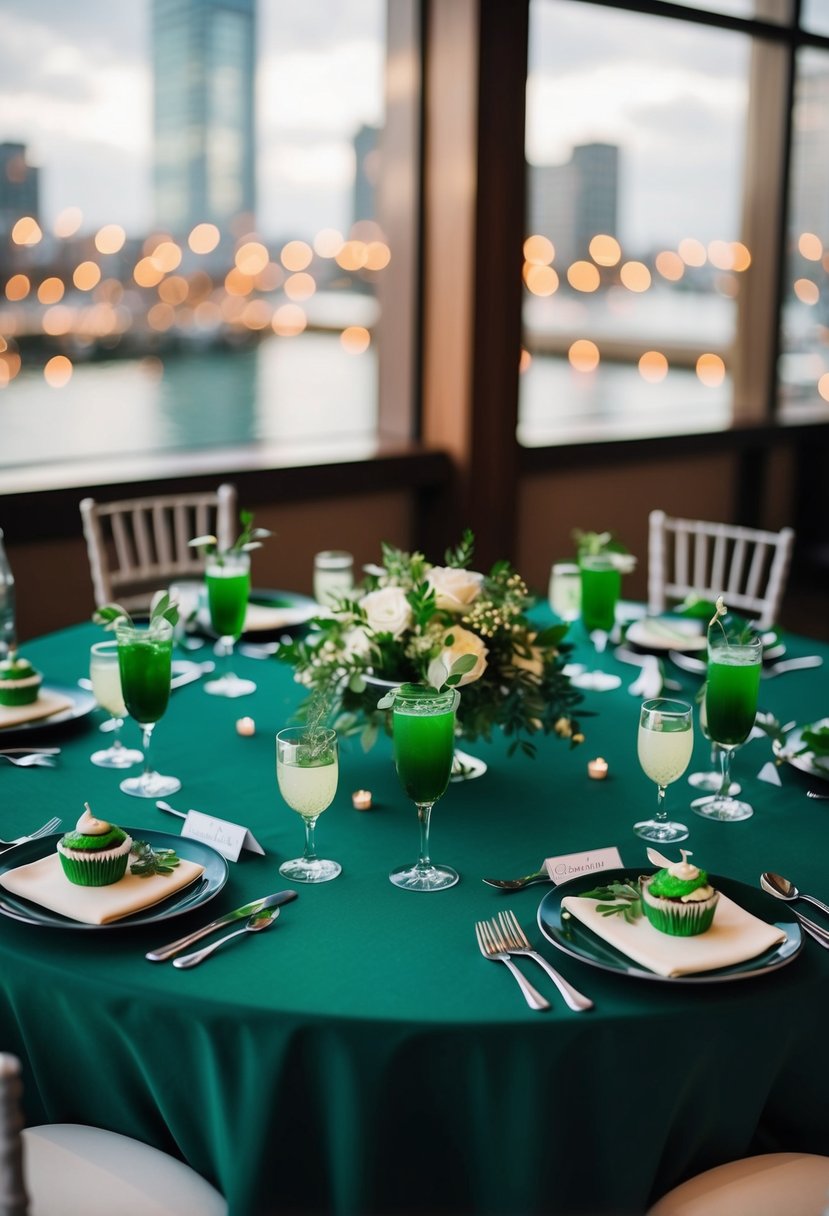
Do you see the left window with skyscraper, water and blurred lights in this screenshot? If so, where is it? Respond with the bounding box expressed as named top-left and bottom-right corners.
top-left (0, 0), bottom-right (394, 478)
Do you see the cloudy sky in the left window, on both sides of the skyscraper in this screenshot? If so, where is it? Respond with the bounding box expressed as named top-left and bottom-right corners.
top-left (0, 0), bottom-right (384, 235)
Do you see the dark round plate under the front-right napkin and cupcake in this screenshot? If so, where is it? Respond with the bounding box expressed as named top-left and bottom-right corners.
top-left (538, 866), bottom-right (803, 984)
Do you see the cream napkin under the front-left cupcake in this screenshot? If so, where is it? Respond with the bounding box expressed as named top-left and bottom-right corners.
top-left (0, 852), bottom-right (204, 924)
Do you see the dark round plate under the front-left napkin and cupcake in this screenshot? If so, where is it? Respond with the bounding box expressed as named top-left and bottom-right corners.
top-left (0, 827), bottom-right (227, 930)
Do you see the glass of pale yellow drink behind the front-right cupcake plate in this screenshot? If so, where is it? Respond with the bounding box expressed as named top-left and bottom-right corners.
top-left (633, 697), bottom-right (694, 844)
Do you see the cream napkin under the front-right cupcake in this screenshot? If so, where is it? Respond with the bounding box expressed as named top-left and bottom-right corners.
top-left (562, 894), bottom-right (785, 975)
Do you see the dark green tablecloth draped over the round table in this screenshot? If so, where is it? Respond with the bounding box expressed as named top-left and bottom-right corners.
top-left (0, 625), bottom-right (829, 1216)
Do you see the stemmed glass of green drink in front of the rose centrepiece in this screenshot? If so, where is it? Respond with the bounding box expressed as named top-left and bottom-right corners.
top-left (383, 683), bottom-right (461, 891)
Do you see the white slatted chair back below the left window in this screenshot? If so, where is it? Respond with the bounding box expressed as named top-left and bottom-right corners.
top-left (80, 484), bottom-right (237, 610)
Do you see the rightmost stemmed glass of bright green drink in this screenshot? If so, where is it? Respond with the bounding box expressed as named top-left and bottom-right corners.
top-left (693, 637), bottom-right (763, 823)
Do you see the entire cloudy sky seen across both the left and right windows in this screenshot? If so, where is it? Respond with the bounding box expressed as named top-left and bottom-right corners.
top-left (0, 0), bottom-right (743, 246)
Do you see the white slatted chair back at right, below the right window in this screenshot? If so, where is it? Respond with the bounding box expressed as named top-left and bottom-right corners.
top-left (648, 511), bottom-right (795, 629)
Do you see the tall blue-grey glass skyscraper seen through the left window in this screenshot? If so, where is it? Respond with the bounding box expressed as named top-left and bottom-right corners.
top-left (152, 0), bottom-right (255, 236)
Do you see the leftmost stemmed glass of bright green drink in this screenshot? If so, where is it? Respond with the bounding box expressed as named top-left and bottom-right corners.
top-left (115, 620), bottom-right (181, 798)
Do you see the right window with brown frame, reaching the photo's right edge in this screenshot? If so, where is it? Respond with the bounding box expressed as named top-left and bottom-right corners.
top-left (518, 0), bottom-right (829, 446)
